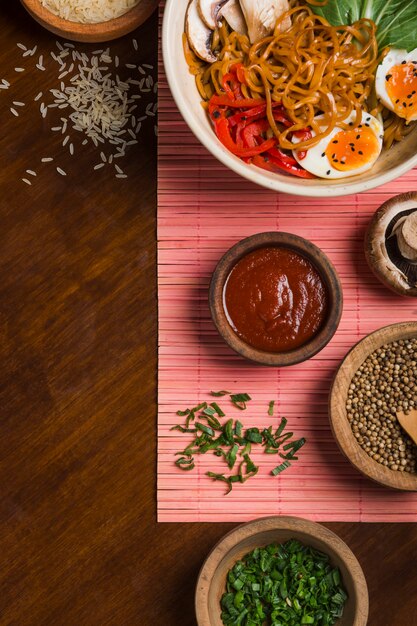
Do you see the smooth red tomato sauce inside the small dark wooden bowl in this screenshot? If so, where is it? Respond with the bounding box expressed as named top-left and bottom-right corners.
top-left (223, 247), bottom-right (328, 352)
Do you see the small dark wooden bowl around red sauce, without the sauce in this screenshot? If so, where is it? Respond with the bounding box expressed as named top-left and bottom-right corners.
top-left (209, 232), bottom-right (343, 367)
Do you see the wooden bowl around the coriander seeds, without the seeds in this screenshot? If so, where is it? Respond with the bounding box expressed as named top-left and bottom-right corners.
top-left (329, 322), bottom-right (417, 491)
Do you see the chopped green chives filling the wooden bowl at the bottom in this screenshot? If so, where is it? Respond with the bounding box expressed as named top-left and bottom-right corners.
top-left (220, 539), bottom-right (348, 626)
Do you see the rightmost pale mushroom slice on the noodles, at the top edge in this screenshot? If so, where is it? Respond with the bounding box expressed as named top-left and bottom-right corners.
top-left (240, 0), bottom-right (291, 43)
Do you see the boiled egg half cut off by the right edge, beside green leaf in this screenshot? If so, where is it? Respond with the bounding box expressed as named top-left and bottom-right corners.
top-left (375, 48), bottom-right (417, 122)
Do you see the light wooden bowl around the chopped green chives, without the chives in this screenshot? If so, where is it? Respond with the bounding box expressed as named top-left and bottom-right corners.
top-left (195, 517), bottom-right (369, 626)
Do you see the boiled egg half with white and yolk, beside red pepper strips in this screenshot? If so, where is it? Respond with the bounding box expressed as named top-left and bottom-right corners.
top-left (292, 112), bottom-right (384, 178)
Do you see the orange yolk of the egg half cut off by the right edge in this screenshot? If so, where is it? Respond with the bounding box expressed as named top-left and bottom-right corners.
top-left (385, 62), bottom-right (417, 120)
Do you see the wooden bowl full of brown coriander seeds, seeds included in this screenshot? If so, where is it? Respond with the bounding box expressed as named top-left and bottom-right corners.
top-left (329, 322), bottom-right (417, 491)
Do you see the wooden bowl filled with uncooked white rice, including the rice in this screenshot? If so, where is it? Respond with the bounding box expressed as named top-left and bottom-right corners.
top-left (21, 0), bottom-right (158, 43)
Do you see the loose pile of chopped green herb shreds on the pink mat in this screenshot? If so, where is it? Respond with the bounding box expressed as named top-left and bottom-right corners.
top-left (171, 391), bottom-right (306, 493)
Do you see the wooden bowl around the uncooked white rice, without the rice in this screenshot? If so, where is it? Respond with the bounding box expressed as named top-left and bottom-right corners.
top-left (21, 0), bottom-right (158, 43)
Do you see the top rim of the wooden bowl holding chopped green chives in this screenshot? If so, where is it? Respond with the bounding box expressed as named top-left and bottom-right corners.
top-left (194, 515), bottom-right (369, 626)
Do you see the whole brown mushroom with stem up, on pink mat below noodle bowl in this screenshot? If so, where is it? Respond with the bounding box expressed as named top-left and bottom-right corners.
top-left (365, 192), bottom-right (417, 297)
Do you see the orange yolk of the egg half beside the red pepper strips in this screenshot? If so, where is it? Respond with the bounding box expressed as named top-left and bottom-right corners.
top-left (322, 125), bottom-right (380, 172)
